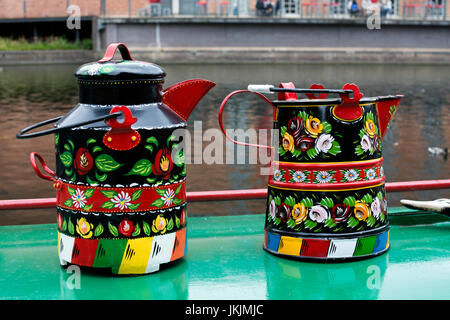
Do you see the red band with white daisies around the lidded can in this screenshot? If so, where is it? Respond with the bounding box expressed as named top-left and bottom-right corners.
top-left (55, 180), bottom-right (186, 213)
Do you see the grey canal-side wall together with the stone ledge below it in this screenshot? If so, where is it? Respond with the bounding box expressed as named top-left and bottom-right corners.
top-left (0, 17), bottom-right (450, 65)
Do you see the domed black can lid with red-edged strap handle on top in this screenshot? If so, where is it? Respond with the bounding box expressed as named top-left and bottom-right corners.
top-left (75, 43), bottom-right (166, 81)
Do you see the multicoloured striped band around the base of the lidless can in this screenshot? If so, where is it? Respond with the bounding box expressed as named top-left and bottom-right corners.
top-left (264, 230), bottom-right (389, 260)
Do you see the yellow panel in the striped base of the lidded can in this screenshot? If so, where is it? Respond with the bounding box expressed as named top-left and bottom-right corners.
top-left (118, 237), bottom-right (153, 274)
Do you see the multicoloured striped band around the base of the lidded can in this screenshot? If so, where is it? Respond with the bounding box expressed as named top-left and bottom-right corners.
top-left (58, 228), bottom-right (187, 274)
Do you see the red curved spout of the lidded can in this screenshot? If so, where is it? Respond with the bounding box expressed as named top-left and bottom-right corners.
top-left (162, 79), bottom-right (216, 121)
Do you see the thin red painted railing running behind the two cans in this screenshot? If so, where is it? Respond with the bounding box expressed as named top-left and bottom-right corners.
top-left (0, 179), bottom-right (450, 210)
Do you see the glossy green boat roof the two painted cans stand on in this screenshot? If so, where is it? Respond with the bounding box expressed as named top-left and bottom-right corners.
top-left (0, 208), bottom-right (450, 300)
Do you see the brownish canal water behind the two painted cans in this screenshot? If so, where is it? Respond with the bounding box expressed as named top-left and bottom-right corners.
top-left (0, 64), bottom-right (450, 225)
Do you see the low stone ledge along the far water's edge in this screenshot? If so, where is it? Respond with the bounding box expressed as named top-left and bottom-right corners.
top-left (0, 47), bottom-right (450, 65)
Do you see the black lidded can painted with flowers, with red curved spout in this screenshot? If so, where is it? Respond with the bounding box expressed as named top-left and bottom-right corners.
top-left (17, 43), bottom-right (214, 274)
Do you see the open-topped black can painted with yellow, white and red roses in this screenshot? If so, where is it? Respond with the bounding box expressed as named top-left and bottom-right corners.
top-left (219, 83), bottom-right (402, 262)
